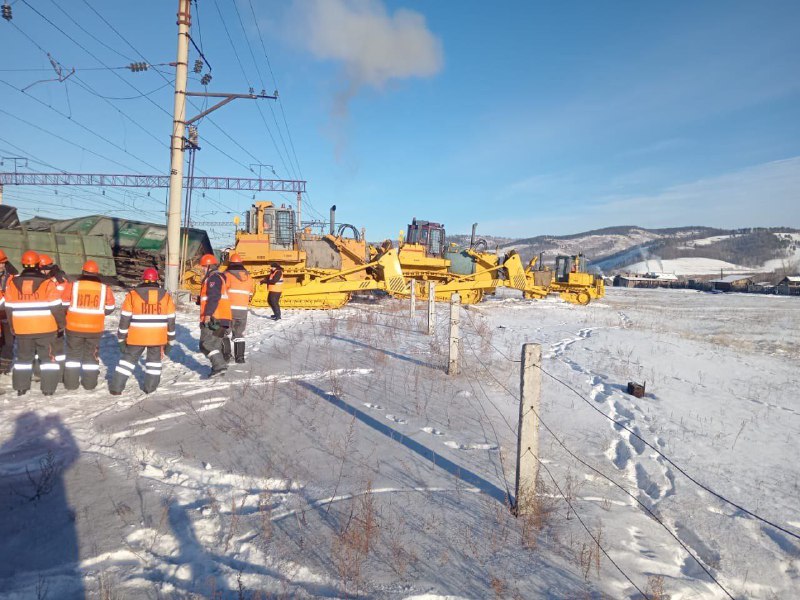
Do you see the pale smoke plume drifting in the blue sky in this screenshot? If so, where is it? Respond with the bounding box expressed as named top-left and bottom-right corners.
top-left (292, 0), bottom-right (444, 155)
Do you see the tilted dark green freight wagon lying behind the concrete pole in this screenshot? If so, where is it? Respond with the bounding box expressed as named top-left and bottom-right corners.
top-left (24, 215), bottom-right (214, 284)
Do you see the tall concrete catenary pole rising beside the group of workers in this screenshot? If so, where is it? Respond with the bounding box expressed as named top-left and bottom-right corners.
top-left (165, 0), bottom-right (191, 292)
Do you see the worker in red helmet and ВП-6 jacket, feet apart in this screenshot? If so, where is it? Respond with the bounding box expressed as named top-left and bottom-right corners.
top-left (108, 268), bottom-right (175, 396)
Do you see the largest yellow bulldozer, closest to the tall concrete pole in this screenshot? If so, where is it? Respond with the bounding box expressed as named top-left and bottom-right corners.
top-left (183, 202), bottom-right (406, 309)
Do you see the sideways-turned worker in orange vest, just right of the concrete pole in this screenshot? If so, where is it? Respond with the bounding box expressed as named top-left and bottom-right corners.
top-left (200, 254), bottom-right (233, 377)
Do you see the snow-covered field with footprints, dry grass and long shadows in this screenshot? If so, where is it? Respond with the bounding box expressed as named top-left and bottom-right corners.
top-left (0, 288), bottom-right (800, 600)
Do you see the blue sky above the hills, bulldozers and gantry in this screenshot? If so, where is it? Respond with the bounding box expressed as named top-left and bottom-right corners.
top-left (0, 0), bottom-right (800, 243)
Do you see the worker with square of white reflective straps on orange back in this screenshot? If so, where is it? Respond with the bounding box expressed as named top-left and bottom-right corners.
top-left (62, 260), bottom-right (116, 390)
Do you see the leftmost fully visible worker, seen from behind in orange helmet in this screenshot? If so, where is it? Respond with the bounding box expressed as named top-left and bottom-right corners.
top-left (3, 250), bottom-right (65, 396)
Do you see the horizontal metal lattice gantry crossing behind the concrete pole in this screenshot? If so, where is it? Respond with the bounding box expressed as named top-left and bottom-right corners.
top-left (0, 172), bottom-right (306, 194)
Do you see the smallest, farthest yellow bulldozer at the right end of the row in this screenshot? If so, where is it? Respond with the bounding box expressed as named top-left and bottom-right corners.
top-left (525, 254), bottom-right (606, 306)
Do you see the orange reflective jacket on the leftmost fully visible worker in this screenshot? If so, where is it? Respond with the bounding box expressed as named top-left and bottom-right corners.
top-left (5, 275), bottom-right (61, 336)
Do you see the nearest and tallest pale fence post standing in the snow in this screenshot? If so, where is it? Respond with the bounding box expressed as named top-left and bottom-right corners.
top-left (514, 344), bottom-right (542, 515)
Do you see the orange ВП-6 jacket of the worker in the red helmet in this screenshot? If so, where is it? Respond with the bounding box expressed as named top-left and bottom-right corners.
top-left (118, 287), bottom-right (175, 346)
